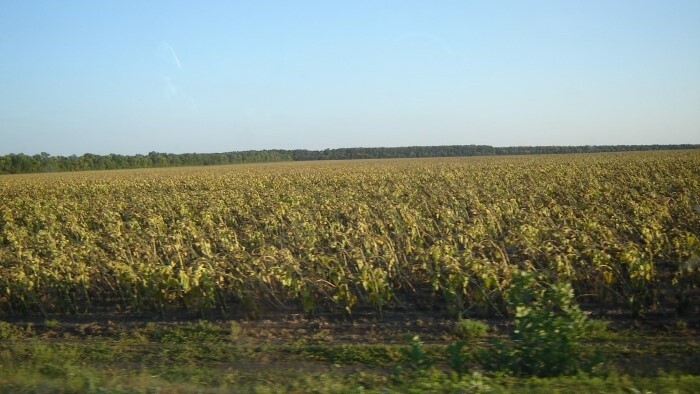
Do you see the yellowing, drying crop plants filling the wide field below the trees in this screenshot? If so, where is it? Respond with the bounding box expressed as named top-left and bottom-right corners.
top-left (0, 150), bottom-right (700, 315)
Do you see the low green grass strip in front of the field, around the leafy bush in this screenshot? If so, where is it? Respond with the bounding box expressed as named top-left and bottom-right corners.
top-left (0, 321), bottom-right (700, 393)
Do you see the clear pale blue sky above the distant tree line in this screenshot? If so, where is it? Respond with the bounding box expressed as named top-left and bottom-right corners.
top-left (0, 0), bottom-right (700, 155)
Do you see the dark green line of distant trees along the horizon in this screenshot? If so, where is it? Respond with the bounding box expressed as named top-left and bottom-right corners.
top-left (0, 144), bottom-right (700, 174)
